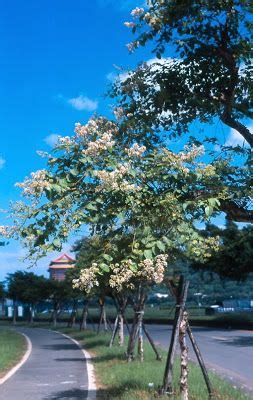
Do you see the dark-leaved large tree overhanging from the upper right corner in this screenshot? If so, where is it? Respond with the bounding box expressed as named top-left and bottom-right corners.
top-left (112, 0), bottom-right (253, 221)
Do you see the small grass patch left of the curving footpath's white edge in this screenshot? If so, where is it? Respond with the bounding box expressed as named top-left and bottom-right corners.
top-left (0, 329), bottom-right (27, 377)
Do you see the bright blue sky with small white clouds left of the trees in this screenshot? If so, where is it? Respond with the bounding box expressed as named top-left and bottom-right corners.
top-left (0, 0), bottom-right (249, 280)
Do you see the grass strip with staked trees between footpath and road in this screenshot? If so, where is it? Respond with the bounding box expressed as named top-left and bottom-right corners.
top-left (57, 328), bottom-right (252, 400)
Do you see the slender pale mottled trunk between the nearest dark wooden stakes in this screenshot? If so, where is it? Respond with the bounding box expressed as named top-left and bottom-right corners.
top-left (179, 311), bottom-right (189, 400)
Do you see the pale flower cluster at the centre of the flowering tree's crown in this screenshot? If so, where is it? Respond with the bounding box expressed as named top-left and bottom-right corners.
top-left (96, 164), bottom-right (139, 192)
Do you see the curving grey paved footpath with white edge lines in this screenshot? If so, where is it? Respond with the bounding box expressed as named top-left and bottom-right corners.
top-left (0, 328), bottom-right (88, 400)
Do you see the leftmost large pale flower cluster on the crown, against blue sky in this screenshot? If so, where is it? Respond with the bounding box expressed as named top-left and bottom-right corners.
top-left (15, 169), bottom-right (50, 196)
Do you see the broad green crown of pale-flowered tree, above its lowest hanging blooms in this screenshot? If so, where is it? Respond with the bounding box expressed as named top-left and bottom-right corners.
top-left (12, 117), bottom-right (229, 259)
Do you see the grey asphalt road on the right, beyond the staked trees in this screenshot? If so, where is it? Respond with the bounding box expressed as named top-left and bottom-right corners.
top-left (144, 325), bottom-right (253, 398)
